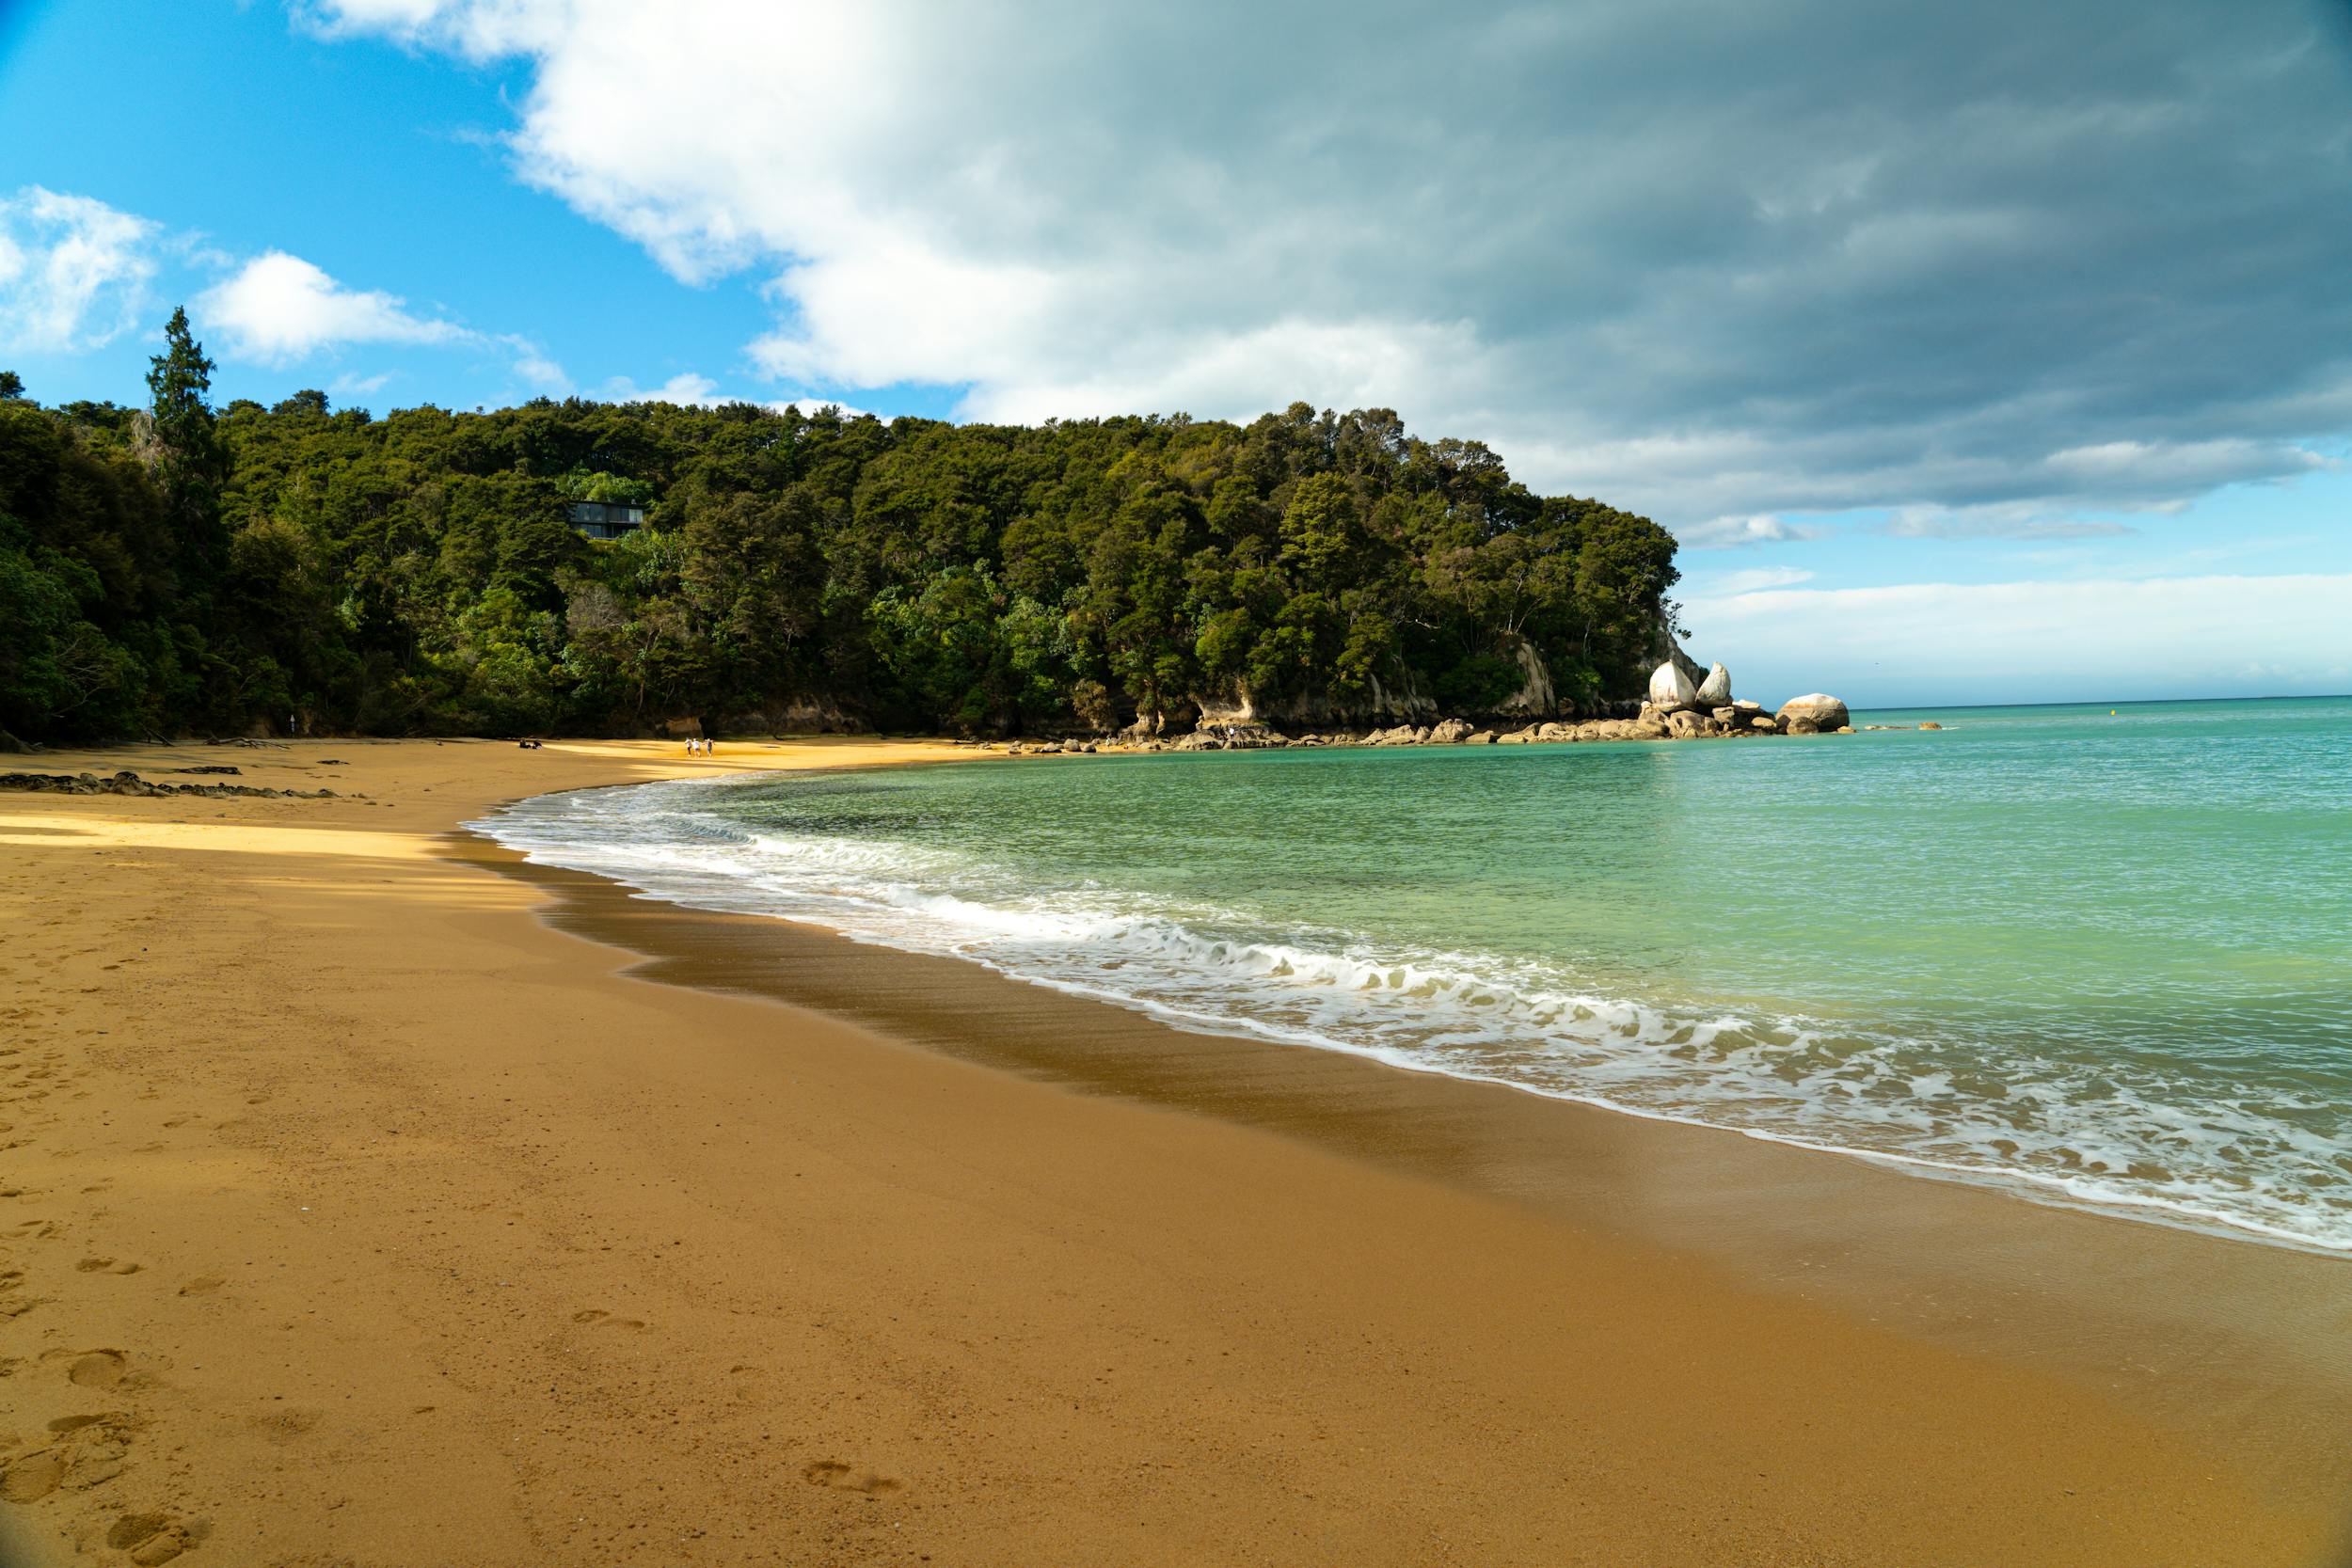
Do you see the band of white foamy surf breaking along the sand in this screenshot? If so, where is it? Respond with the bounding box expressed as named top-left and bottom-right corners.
top-left (475, 783), bottom-right (2352, 1253)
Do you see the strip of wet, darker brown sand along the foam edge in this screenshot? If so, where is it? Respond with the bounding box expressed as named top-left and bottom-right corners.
top-left (452, 828), bottom-right (2352, 1497)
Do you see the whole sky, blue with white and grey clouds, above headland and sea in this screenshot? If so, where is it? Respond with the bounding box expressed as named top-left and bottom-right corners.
top-left (0, 0), bottom-right (2352, 705)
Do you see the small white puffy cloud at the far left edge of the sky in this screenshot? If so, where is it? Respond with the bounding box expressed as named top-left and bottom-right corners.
top-left (0, 185), bottom-right (158, 353)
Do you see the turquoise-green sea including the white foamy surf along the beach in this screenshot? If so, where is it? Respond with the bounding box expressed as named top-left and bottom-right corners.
top-left (487, 698), bottom-right (2352, 1251)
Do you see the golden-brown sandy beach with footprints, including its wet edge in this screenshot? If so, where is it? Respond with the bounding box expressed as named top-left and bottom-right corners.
top-left (0, 740), bottom-right (2352, 1568)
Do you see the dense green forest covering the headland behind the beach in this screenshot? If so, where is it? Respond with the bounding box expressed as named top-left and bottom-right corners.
top-left (0, 312), bottom-right (1677, 740)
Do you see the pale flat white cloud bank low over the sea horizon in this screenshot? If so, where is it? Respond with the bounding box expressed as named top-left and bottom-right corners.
top-left (1682, 574), bottom-right (2352, 703)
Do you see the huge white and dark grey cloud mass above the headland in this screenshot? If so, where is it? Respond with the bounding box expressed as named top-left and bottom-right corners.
top-left (306, 0), bottom-right (2352, 527)
